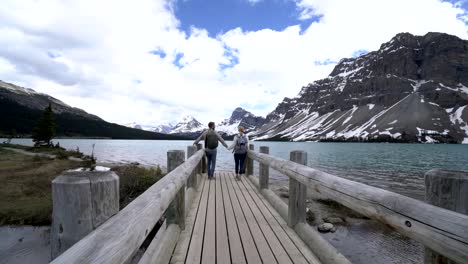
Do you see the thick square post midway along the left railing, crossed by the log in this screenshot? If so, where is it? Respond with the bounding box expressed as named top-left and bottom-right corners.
top-left (167, 150), bottom-right (185, 230)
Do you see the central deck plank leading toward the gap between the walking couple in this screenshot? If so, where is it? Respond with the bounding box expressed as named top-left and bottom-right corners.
top-left (219, 172), bottom-right (247, 264)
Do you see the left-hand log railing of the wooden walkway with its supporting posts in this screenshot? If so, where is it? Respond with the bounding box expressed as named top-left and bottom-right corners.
top-left (52, 146), bottom-right (204, 264)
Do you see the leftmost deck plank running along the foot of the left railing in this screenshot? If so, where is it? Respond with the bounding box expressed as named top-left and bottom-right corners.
top-left (171, 177), bottom-right (207, 264)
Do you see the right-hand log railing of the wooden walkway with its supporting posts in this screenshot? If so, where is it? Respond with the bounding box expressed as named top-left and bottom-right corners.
top-left (247, 146), bottom-right (468, 263)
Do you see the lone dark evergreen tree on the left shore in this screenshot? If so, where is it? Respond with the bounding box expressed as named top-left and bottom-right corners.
top-left (32, 103), bottom-right (56, 146)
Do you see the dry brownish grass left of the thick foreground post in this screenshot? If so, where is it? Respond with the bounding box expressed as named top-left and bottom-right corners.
top-left (0, 148), bottom-right (87, 225)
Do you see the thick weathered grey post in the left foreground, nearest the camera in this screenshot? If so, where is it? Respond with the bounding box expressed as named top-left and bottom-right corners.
top-left (50, 171), bottom-right (119, 259)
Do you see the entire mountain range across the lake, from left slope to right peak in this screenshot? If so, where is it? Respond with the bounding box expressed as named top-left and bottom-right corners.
top-left (0, 33), bottom-right (468, 143)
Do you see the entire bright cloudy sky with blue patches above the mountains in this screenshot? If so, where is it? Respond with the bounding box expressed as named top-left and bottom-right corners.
top-left (0, 0), bottom-right (468, 125)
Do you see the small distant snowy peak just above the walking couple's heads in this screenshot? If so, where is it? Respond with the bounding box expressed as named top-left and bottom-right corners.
top-left (216, 107), bottom-right (265, 136)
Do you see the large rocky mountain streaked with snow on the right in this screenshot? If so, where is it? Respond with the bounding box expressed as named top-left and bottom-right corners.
top-left (252, 33), bottom-right (468, 143)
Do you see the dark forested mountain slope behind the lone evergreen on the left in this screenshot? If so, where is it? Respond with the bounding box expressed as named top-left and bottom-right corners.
top-left (0, 81), bottom-right (185, 140)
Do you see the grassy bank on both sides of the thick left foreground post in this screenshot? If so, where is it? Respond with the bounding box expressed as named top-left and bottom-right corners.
top-left (0, 144), bottom-right (163, 225)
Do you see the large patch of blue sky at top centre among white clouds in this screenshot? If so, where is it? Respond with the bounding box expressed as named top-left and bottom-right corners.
top-left (174, 0), bottom-right (320, 37)
